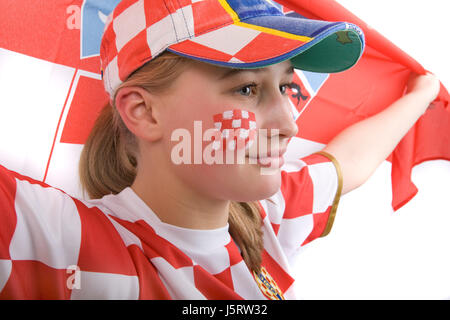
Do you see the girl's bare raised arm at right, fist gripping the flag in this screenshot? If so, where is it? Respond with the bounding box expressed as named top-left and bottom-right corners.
top-left (323, 74), bottom-right (440, 194)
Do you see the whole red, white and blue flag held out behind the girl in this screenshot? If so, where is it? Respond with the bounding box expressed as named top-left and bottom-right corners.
top-left (0, 0), bottom-right (450, 210)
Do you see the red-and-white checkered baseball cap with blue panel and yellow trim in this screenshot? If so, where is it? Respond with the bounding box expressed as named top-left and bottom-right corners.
top-left (100, 0), bottom-right (364, 97)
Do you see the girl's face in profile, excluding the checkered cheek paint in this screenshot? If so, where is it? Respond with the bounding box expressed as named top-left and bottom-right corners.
top-left (153, 61), bottom-right (297, 201)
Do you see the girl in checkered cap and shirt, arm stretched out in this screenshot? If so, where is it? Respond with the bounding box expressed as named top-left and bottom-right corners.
top-left (0, 0), bottom-right (439, 299)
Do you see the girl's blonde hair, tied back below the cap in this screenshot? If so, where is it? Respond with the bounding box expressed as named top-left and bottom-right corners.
top-left (79, 52), bottom-right (263, 273)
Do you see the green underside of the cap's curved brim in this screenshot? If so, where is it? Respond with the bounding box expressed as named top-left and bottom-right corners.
top-left (290, 30), bottom-right (362, 73)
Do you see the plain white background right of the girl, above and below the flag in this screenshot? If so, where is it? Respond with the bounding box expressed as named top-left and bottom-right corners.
top-left (296, 0), bottom-right (450, 299)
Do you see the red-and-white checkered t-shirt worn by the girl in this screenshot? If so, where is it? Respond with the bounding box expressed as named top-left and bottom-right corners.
top-left (0, 153), bottom-right (342, 299)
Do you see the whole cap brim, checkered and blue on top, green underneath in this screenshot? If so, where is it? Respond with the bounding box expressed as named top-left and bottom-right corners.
top-left (167, 15), bottom-right (364, 73)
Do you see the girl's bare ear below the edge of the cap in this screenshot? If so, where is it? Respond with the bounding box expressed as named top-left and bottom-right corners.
top-left (116, 87), bottom-right (163, 141)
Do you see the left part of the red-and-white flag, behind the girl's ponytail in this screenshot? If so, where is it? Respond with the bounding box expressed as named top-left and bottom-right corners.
top-left (0, 0), bottom-right (120, 197)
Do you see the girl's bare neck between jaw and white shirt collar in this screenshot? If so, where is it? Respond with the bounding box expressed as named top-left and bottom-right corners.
top-left (131, 154), bottom-right (230, 230)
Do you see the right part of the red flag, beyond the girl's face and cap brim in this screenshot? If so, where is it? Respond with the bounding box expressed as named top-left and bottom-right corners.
top-left (278, 0), bottom-right (450, 210)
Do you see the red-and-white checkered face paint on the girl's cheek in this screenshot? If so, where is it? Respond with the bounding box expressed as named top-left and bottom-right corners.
top-left (213, 109), bottom-right (256, 151)
